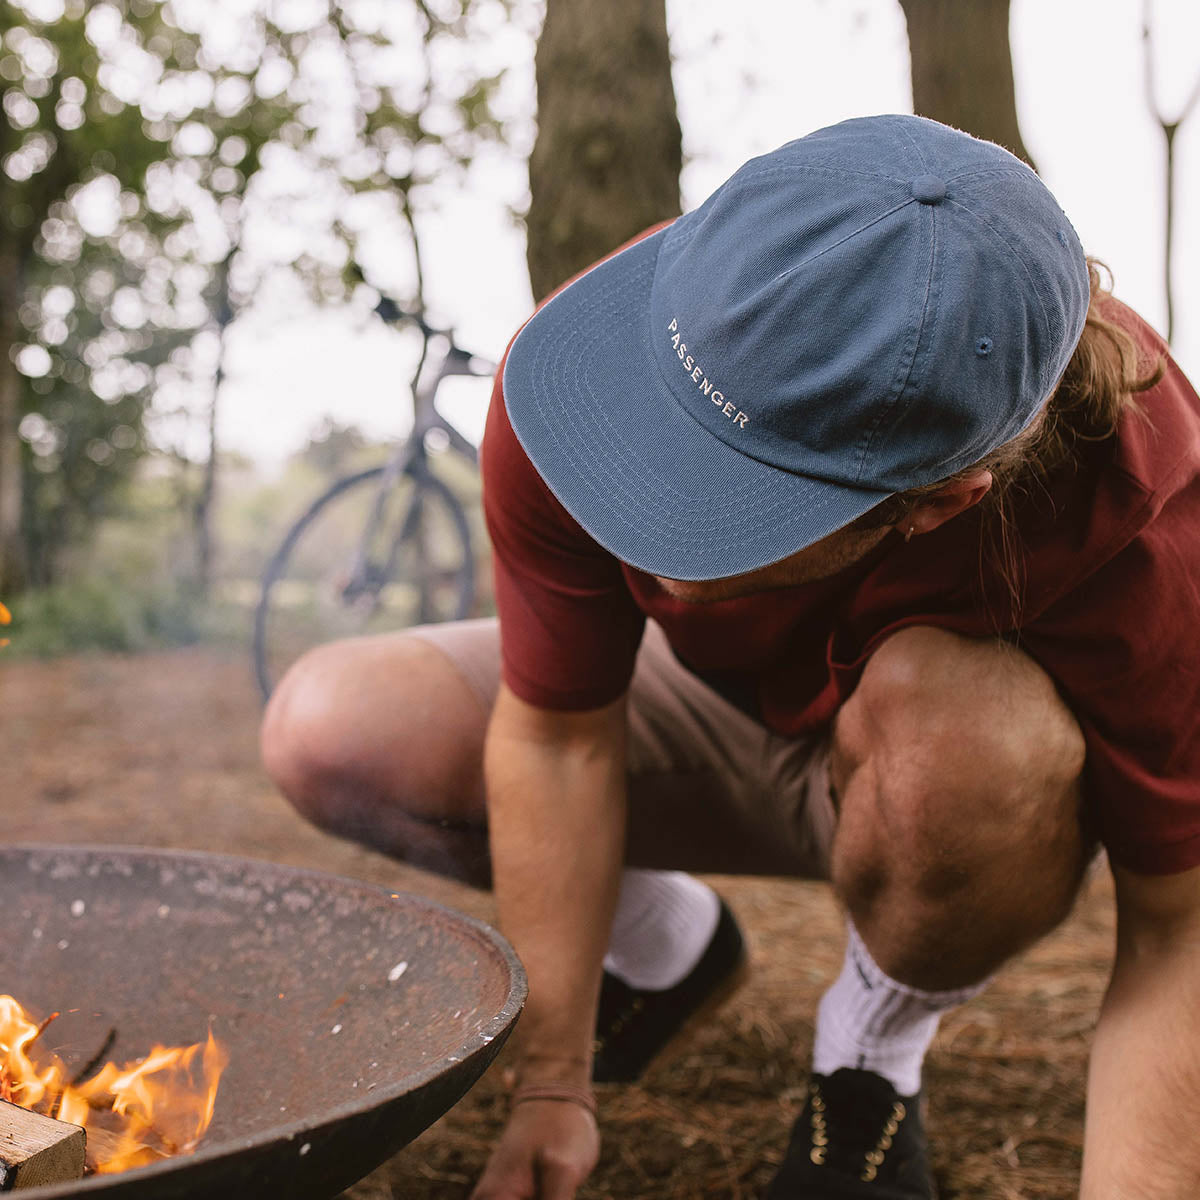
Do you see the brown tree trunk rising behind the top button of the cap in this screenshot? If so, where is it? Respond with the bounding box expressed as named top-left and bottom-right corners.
top-left (900, 0), bottom-right (1036, 169)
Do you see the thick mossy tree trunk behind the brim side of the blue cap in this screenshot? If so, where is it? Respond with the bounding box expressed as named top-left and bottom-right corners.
top-left (527, 0), bottom-right (683, 299)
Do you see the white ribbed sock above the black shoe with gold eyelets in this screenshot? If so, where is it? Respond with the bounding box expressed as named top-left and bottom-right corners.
top-left (812, 920), bottom-right (986, 1096)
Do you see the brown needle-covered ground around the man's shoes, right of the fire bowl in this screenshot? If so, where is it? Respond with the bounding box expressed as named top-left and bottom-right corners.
top-left (372, 876), bottom-right (1112, 1200)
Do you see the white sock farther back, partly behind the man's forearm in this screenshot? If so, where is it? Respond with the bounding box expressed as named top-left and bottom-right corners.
top-left (604, 866), bottom-right (720, 991)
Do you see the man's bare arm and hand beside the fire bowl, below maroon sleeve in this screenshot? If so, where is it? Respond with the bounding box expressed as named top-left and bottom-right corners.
top-left (475, 686), bottom-right (625, 1200)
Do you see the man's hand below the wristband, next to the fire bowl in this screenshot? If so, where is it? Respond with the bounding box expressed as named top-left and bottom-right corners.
top-left (470, 1100), bottom-right (600, 1200)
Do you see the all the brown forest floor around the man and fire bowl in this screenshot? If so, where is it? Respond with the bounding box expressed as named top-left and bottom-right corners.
top-left (0, 649), bottom-right (1112, 1200)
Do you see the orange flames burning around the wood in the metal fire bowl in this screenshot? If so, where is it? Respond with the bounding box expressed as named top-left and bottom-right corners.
top-left (0, 996), bottom-right (229, 1172)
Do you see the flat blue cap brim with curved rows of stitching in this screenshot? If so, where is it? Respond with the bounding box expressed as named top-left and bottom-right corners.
top-left (504, 230), bottom-right (890, 580)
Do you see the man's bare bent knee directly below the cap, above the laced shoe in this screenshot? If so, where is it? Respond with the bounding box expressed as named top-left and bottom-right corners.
top-left (833, 626), bottom-right (1090, 948)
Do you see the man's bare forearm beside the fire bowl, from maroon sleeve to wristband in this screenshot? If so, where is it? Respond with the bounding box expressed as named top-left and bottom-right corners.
top-left (485, 690), bottom-right (625, 1084)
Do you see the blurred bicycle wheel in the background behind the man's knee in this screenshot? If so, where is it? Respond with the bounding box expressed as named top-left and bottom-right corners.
top-left (253, 466), bottom-right (475, 700)
